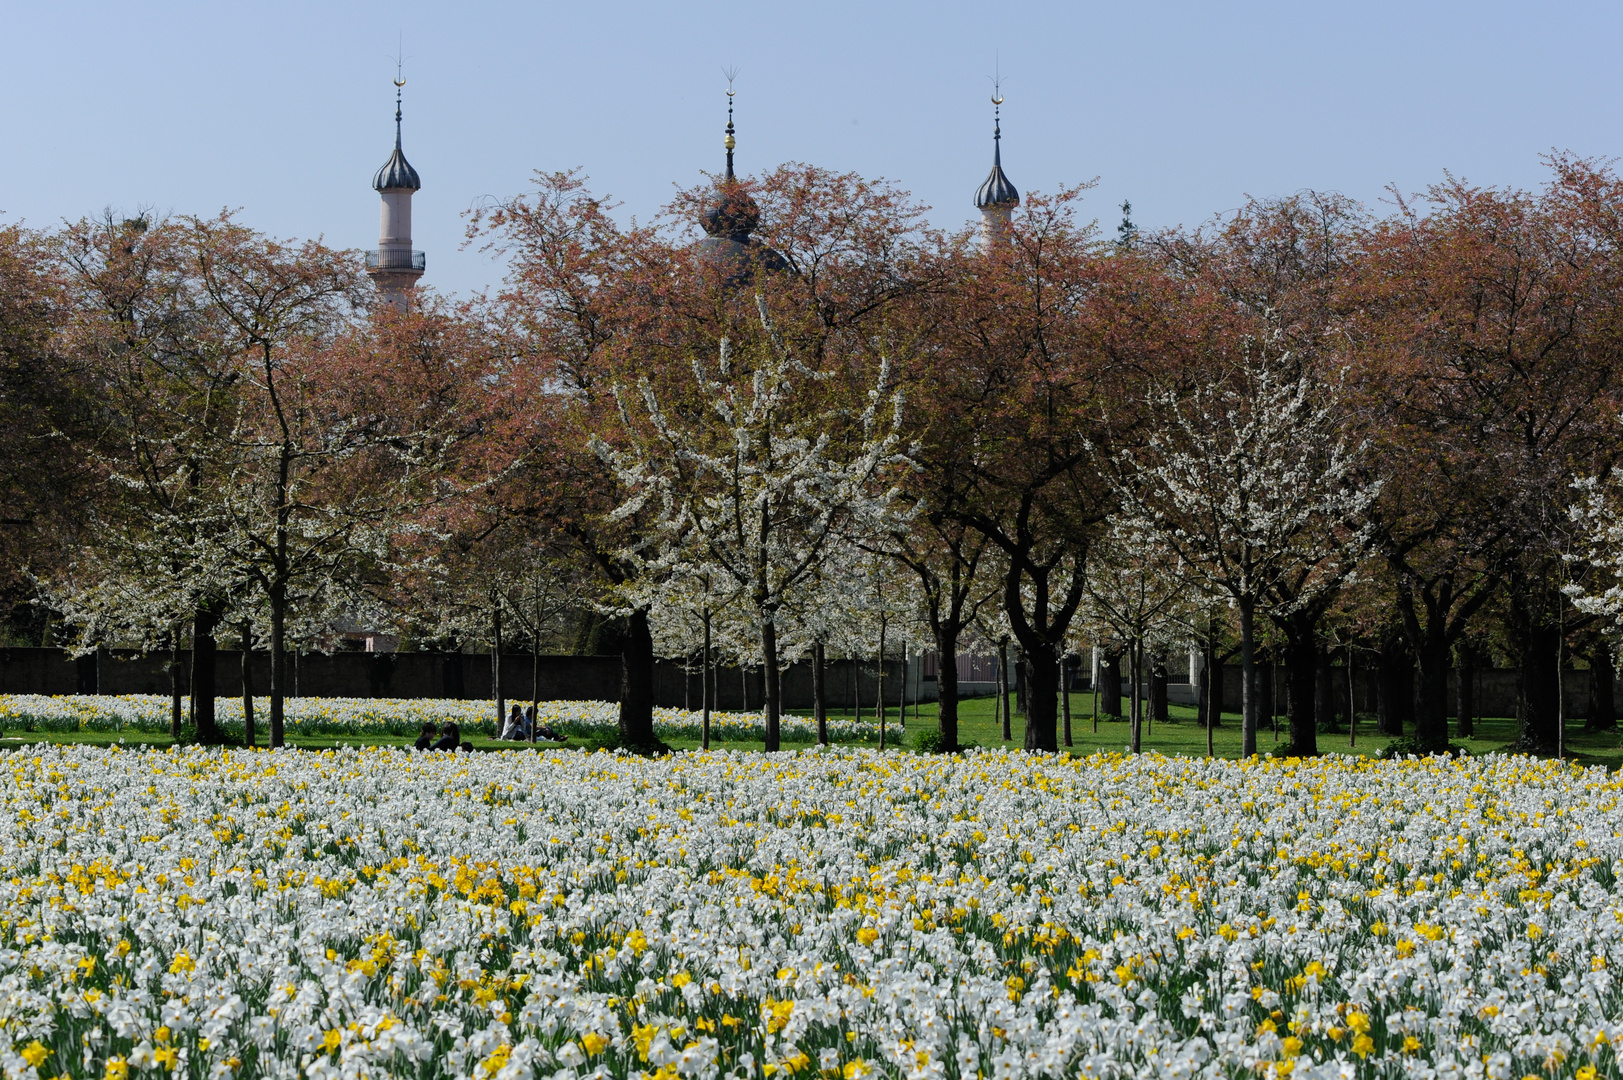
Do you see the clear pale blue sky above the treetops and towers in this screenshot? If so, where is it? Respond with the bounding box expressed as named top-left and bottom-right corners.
top-left (0, 0), bottom-right (1623, 296)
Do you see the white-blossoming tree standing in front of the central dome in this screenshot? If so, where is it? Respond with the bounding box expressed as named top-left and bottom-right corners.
top-left (597, 297), bottom-right (902, 750)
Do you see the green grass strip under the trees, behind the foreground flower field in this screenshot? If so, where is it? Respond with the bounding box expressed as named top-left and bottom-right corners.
top-left (0, 693), bottom-right (1623, 770)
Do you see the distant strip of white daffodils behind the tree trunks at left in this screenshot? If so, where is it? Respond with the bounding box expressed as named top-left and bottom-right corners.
top-left (0, 693), bottom-right (882, 742)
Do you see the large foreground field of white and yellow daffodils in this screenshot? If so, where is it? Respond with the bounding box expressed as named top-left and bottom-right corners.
top-left (0, 745), bottom-right (1623, 1080)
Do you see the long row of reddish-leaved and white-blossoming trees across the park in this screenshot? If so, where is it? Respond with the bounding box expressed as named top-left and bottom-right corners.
top-left (9, 158), bottom-right (1623, 754)
